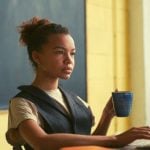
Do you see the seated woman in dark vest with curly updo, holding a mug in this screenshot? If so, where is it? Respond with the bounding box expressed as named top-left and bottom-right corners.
top-left (6, 17), bottom-right (150, 150)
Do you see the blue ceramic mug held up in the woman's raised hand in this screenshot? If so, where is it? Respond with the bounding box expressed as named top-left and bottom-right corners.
top-left (112, 91), bottom-right (133, 117)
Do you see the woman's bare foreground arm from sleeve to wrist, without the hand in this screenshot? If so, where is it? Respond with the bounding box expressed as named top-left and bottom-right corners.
top-left (19, 120), bottom-right (116, 150)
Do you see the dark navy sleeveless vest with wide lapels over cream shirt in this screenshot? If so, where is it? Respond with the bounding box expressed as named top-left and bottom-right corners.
top-left (15, 85), bottom-right (92, 150)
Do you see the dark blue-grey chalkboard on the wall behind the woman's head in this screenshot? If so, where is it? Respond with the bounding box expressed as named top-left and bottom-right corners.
top-left (0, 0), bottom-right (86, 109)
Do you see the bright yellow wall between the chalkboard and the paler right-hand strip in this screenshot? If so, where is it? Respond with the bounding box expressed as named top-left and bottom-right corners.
top-left (86, 0), bottom-right (130, 133)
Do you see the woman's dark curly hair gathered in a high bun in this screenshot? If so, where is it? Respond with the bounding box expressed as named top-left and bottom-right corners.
top-left (18, 17), bottom-right (69, 67)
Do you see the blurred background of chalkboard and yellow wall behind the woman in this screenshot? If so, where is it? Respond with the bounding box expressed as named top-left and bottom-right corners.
top-left (0, 0), bottom-right (150, 150)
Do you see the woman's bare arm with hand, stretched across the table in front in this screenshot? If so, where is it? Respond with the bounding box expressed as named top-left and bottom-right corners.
top-left (19, 120), bottom-right (150, 150)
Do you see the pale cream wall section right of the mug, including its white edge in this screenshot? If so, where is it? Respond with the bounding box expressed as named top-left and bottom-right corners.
top-left (129, 0), bottom-right (150, 126)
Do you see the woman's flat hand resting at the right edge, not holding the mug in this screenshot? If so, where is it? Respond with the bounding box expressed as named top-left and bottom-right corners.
top-left (114, 127), bottom-right (150, 147)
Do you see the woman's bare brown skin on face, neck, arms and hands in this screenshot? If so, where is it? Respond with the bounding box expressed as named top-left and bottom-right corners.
top-left (14, 34), bottom-right (150, 150)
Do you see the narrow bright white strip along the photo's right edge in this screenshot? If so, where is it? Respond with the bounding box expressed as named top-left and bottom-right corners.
top-left (143, 0), bottom-right (150, 125)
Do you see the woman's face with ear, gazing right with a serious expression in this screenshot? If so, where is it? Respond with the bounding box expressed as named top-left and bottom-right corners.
top-left (33, 34), bottom-right (76, 79)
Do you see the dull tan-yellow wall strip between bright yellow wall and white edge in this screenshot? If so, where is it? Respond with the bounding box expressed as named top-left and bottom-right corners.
top-left (129, 0), bottom-right (146, 126)
